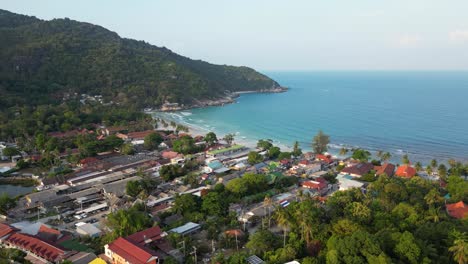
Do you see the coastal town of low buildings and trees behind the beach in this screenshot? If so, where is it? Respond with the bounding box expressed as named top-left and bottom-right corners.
top-left (0, 120), bottom-right (468, 263)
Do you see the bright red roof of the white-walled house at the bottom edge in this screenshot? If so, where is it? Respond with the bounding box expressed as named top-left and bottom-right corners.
top-left (109, 237), bottom-right (157, 264)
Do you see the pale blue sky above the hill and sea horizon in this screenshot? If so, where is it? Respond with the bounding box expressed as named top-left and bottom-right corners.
top-left (0, 0), bottom-right (468, 70)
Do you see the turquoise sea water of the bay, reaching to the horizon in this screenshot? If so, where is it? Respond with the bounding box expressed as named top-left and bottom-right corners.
top-left (154, 72), bottom-right (468, 162)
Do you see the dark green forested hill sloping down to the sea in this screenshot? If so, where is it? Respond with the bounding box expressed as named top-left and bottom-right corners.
top-left (0, 10), bottom-right (279, 108)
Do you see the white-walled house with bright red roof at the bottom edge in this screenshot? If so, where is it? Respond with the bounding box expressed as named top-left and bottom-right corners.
top-left (104, 237), bottom-right (159, 264)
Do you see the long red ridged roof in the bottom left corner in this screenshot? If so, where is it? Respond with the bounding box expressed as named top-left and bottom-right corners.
top-left (6, 233), bottom-right (65, 262)
